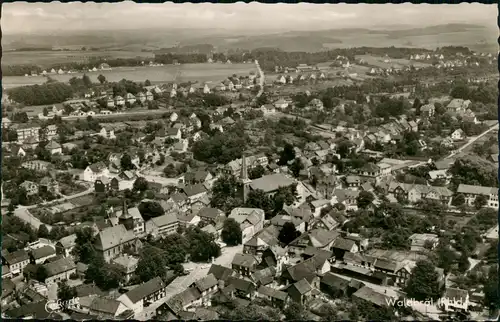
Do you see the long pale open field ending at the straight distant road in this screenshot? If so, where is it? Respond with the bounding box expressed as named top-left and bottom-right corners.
top-left (2, 63), bottom-right (256, 88)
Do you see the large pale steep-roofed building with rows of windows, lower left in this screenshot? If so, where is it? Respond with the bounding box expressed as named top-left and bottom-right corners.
top-left (94, 224), bottom-right (140, 262)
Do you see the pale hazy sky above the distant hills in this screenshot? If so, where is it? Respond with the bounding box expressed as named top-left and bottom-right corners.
top-left (1, 1), bottom-right (498, 34)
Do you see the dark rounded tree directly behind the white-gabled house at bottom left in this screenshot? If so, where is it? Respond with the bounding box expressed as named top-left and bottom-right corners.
top-left (136, 245), bottom-right (168, 282)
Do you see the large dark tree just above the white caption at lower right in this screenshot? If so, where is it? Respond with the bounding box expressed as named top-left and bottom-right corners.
top-left (405, 261), bottom-right (442, 301)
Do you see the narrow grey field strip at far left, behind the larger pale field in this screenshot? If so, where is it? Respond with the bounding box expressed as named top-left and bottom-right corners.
top-left (2, 50), bottom-right (154, 68)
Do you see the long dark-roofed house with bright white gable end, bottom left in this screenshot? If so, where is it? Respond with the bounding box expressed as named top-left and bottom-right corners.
top-left (117, 277), bottom-right (167, 314)
